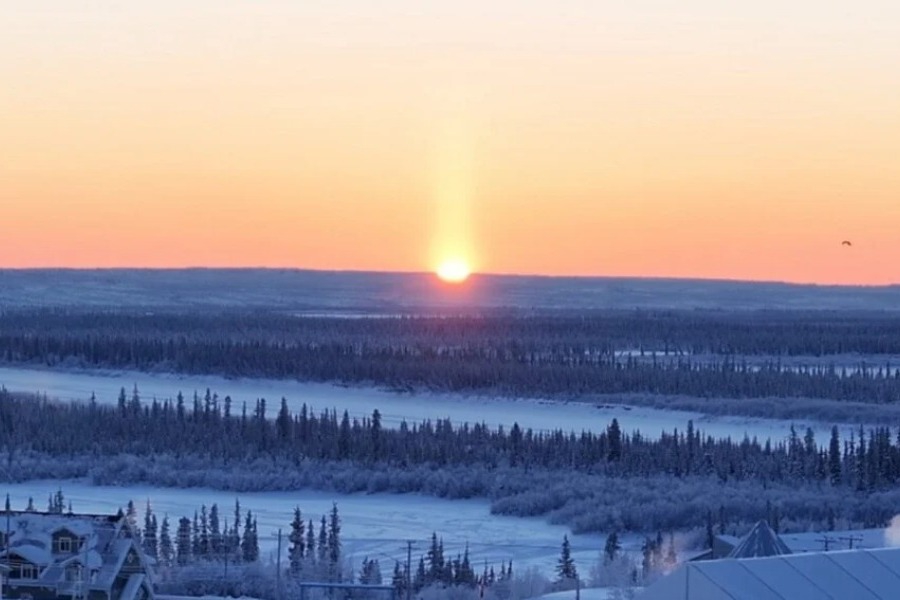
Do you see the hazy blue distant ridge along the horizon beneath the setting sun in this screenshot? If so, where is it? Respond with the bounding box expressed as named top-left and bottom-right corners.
top-left (0, 268), bottom-right (900, 313)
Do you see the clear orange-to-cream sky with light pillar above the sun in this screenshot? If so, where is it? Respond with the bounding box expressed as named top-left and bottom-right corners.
top-left (0, 0), bottom-right (900, 284)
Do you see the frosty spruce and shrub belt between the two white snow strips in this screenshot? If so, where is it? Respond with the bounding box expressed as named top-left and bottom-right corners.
top-left (0, 389), bottom-right (900, 532)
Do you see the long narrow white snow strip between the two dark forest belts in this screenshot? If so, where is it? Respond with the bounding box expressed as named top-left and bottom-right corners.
top-left (0, 368), bottom-right (858, 444)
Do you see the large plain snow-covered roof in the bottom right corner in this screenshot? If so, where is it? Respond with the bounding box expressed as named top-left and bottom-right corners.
top-left (638, 548), bottom-right (900, 600)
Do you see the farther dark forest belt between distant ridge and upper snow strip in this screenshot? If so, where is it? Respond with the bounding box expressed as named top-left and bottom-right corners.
top-left (0, 310), bottom-right (900, 414)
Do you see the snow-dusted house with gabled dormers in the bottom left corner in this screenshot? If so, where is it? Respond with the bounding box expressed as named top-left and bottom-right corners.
top-left (0, 511), bottom-right (153, 600)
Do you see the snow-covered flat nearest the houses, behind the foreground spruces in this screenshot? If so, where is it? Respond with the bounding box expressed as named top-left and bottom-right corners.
top-left (0, 481), bottom-right (612, 576)
